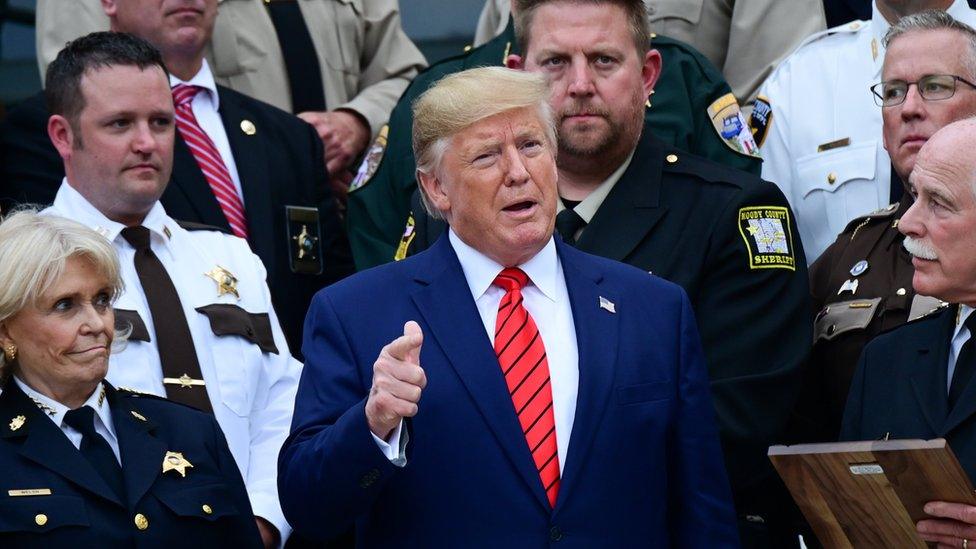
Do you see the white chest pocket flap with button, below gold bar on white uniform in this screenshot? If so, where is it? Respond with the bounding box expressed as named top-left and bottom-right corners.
top-left (796, 141), bottom-right (878, 198)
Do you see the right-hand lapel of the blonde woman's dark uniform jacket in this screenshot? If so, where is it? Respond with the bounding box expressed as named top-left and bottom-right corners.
top-left (106, 383), bottom-right (166, 505)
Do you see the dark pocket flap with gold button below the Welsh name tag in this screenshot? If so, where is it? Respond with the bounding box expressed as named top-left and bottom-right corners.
top-left (0, 496), bottom-right (90, 532)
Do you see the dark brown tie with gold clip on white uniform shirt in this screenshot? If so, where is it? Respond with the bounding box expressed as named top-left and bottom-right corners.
top-left (122, 226), bottom-right (213, 412)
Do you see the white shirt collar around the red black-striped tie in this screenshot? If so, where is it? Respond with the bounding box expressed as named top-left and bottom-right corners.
top-left (448, 229), bottom-right (559, 301)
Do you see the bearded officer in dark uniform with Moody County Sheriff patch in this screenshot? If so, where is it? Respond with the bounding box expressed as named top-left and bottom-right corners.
top-left (403, 0), bottom-right (812, 547)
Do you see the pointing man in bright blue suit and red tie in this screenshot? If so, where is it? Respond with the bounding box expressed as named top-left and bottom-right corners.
top-left (279, 67), bottom-right (738, 547)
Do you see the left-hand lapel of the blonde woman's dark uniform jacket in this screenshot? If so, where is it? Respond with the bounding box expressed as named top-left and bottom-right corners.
top-left (0, 381), bottom-right (124, 507)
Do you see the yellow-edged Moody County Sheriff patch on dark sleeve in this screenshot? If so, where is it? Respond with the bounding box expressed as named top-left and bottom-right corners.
top-left (739, 206), bottom-right (796, 271)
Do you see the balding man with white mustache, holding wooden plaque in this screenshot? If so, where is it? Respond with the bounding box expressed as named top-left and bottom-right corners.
top-left (841, 118), bottom-right (976, 548)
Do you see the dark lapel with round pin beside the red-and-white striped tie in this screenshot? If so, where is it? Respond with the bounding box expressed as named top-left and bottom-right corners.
top-left (217, 86), bottom-right (276, 257)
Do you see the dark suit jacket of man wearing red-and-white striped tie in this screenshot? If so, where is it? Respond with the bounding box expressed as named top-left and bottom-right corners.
top-left (0, 90), bottom-right (352, 354)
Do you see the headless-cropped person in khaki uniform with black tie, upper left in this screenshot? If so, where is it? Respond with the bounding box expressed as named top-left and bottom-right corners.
top-left (37, 0), bottom-right (426, 179)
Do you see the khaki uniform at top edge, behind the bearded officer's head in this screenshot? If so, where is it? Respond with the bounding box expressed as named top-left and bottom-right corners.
top-left (475, 0), bottom-right (827, 105)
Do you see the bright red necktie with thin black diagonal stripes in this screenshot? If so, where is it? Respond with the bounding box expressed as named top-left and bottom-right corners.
top-left (493, 268), bottom-right (559, 507)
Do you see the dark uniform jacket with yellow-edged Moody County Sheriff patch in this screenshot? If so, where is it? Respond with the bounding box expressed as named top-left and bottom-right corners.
top-left (410, 132), bottom-right (813, 542)
